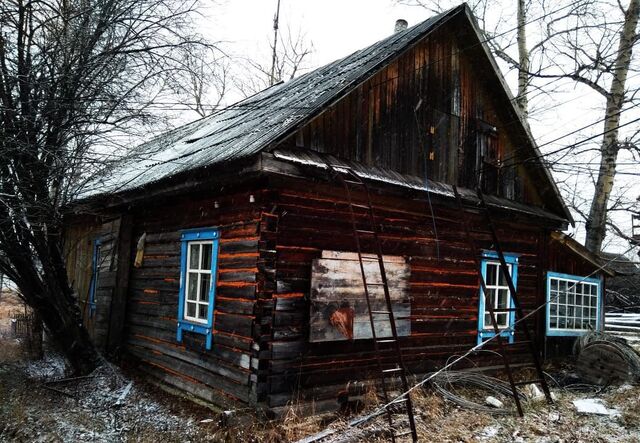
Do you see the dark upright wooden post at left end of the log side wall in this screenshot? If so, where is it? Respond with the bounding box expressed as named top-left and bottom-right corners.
top-left (106, 214), bottom-right (133, 357)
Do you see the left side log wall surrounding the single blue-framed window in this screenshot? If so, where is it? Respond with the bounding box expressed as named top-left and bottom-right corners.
top-left (120, 191), bottom-right (268, 406)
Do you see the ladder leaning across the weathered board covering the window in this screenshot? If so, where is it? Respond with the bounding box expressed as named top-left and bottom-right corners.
top-left (327, 163), bottom-right (418, 442)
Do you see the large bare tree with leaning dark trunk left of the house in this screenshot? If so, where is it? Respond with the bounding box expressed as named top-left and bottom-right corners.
top-left (0, 0), bottom-right (216, 373)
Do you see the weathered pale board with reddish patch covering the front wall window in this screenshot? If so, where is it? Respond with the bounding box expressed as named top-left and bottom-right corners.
top-left (310, 251), bottom-right (411, 342)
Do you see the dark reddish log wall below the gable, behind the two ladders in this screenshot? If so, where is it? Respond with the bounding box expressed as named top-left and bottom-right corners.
top-left (263, 176), bottom-right (545, 409)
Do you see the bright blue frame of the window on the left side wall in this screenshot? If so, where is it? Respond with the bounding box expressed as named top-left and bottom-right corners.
top-left (176, 228), bottom-right (220, 350)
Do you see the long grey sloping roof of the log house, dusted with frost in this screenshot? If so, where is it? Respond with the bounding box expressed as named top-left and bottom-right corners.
top-left (81, 6), bottom-right (456, 198)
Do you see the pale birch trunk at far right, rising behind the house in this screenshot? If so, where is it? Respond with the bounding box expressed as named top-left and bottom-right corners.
top-left (585, 0), bottom-right (640, 253)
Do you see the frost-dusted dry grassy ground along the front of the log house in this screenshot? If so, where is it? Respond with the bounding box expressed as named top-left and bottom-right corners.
top-left (0, 350), bottom-right (640, 443)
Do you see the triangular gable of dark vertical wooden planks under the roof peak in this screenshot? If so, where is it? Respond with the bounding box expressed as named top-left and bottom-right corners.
top-left (280, 23), bottom-right (544, 211)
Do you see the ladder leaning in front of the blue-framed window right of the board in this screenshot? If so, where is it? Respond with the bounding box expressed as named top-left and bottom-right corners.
top-left (453, 186), bottom-right (553, 417)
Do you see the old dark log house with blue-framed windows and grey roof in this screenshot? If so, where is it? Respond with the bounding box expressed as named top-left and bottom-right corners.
top-left (65, 5), bottom-right (604, 414)
